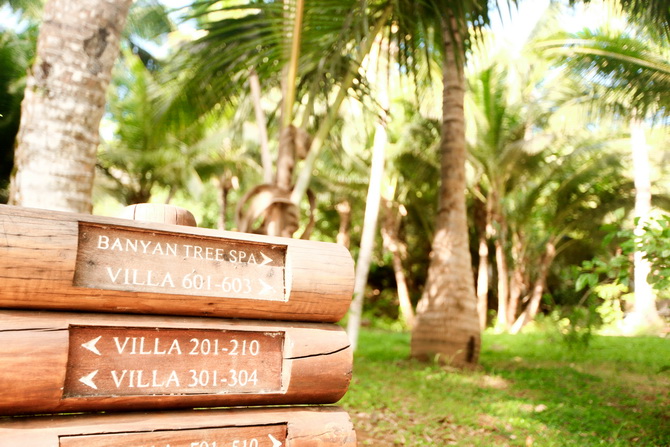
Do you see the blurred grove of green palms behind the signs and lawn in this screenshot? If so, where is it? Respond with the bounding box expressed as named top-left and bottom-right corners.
top-left (0, 0), bottom-right (670, 360)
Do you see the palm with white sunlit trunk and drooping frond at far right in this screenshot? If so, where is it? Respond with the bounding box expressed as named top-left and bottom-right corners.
top-left (540, 2), bottom-right (670, 332)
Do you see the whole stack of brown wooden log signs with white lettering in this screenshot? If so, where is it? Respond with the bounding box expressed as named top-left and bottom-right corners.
top-left (0, 206), bottom-right (356, 447)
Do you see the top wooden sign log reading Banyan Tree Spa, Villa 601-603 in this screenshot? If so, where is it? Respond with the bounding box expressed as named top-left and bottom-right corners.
top-left (0, 205), bottom-right (354, 322)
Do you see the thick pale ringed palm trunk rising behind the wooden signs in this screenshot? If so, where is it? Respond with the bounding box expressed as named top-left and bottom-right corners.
top-left (10, 0), bottom-right (132, 213)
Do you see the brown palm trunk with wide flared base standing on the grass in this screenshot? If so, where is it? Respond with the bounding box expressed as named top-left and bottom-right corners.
top-left (411, 17), bottom-right (481, 366)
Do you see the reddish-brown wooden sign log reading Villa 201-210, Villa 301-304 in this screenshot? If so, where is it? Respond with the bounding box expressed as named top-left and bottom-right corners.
top-left (0, 310), bottom-right (352, 415)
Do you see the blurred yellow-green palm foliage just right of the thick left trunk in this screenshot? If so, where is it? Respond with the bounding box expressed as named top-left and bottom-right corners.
top-left (97, 49), bottom-right (218, 205)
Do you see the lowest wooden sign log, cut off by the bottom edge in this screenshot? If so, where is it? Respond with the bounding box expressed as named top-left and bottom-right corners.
top-left (0, 407), bottom-right (356, 447)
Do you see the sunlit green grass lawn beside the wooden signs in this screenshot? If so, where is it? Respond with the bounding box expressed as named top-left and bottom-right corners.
top-left (340, 330), bottom-right (670, 447)
